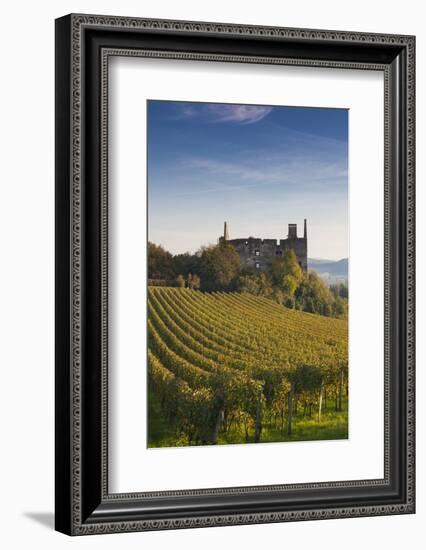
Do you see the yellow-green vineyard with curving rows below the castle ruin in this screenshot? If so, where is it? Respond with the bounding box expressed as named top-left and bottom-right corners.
top-left (148, 287), bottom-right (348, 447)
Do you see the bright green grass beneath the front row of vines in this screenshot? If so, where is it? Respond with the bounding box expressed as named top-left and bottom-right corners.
top-left (148, 393), bottom-right (348, 447)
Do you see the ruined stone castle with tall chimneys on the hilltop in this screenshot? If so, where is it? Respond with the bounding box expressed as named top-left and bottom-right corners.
top-left (219, 219), bottom-right (308, 273)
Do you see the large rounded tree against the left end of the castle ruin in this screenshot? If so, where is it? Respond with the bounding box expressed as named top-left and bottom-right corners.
top-left (199, 242), bottom-right (240, 291)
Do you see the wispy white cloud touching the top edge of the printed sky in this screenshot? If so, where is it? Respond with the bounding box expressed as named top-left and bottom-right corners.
top-left (174, 103), bottom-right (273, 124)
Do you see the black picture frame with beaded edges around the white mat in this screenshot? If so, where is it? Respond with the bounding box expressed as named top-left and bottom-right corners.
top-left (55, 14), bottom-right (415, 535)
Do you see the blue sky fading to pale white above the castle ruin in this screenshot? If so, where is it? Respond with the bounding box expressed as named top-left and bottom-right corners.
top-left (147, 100), bottom-right (348, 260)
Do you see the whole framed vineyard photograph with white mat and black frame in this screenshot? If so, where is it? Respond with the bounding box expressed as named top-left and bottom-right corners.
top-left (55, 14), bottom-right (415, 535)
